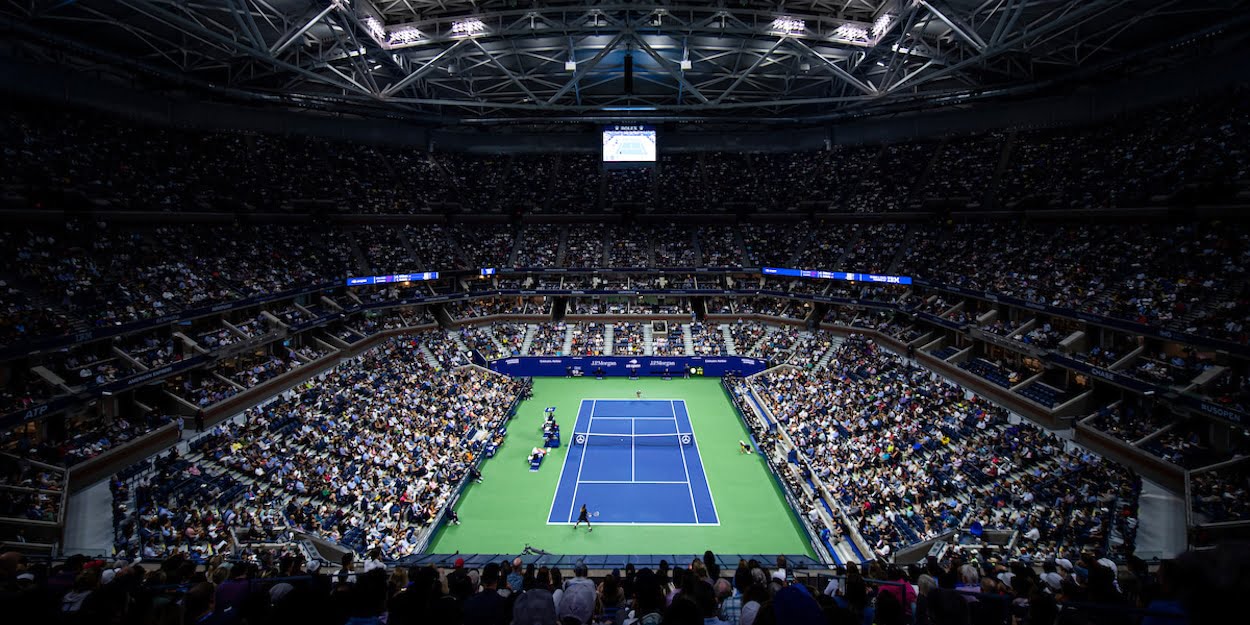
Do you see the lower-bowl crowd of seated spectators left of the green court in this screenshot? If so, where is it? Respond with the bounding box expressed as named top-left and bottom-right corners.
top-left (113, 334), bottom-right (523, 558)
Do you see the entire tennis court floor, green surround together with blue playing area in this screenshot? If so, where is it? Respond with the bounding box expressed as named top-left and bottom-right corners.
top-left (428, 376), bottom-right (813, 563)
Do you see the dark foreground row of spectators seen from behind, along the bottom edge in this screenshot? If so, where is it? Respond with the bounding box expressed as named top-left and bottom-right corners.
top-left (0, 549), bottom-right (1241, 625)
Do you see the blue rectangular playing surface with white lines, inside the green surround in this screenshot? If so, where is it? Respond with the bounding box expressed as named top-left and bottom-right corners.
top-left (548, 399), bottom-right (720, 525)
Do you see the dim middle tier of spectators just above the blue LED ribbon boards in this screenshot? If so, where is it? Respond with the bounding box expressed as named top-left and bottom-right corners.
top-left (8, 220), bottom-right (1250, 351)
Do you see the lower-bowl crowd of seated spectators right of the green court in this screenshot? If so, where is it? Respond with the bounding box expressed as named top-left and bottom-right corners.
top-left (756, 335), bottom-right (1140, 560)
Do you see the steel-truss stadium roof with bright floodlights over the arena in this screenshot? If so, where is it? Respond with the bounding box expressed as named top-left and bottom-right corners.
top-left (0, 0), bottom-right (1250, 123)
